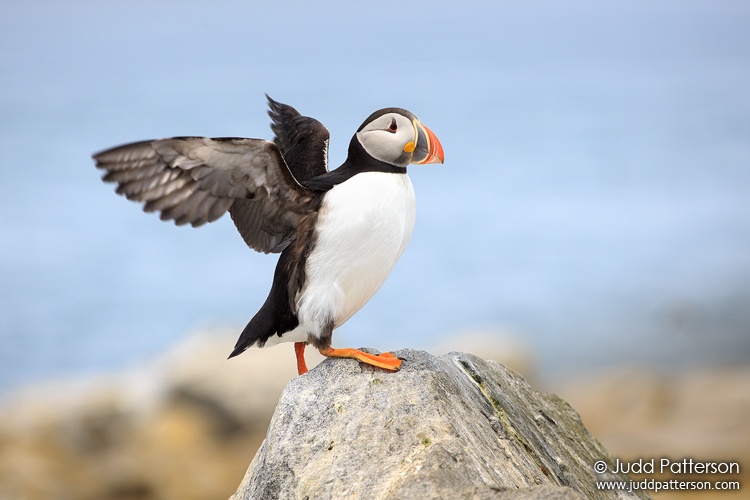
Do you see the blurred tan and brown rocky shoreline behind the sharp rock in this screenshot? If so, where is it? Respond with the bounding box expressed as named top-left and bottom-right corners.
top-left (0, 332), bottom-right (750, 500)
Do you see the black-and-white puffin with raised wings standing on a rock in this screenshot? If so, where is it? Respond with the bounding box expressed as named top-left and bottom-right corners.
top-left (93, 95), bottom-right (444, 375)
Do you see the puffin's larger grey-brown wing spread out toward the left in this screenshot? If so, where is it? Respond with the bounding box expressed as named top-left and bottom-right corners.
top-left (94, 137), bottom-right (315, 253)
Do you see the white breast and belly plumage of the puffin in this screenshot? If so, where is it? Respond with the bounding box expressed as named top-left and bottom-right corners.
top-left (294, 172), bottom-right (416, 341)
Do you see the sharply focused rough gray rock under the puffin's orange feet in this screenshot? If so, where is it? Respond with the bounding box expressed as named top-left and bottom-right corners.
top-left (232, 350), bottom-right (648, 500)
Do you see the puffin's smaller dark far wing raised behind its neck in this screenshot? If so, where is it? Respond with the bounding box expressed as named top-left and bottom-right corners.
top-left (266, 95), bottom-right (330, 182)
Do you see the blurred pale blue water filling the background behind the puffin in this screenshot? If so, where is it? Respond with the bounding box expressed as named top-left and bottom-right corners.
top-left (0, 1), bottom-right (750, 391)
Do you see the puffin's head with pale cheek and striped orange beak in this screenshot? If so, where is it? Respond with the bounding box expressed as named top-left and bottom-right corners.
top-left (356, 108), bottom-right (443, 167)
